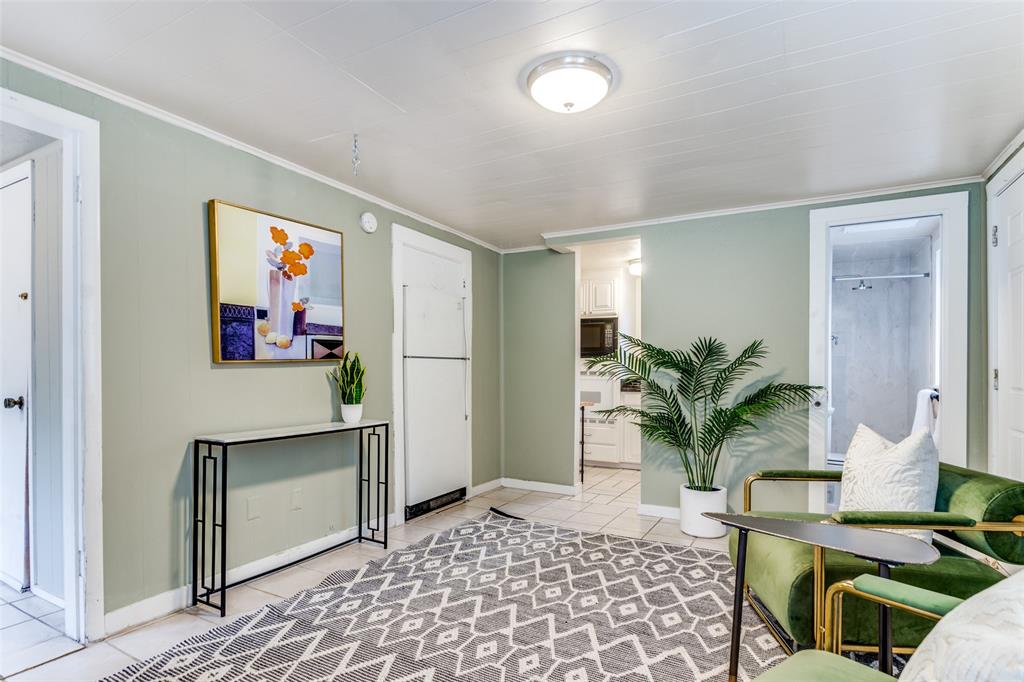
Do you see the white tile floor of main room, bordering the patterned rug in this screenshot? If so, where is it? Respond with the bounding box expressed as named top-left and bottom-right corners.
top-left (10, 468), bottom-right (726, 682)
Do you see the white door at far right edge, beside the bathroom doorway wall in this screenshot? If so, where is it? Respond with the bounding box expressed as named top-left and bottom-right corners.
top-left (989, 171), bottom-right (1024, 480)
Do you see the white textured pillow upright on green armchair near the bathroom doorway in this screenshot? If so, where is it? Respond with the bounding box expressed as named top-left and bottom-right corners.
top-left (839, 424), bottom-right (939, 542)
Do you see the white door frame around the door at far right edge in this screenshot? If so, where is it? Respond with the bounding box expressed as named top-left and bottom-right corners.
top-left (985, 147), bottom-right (1024, 472)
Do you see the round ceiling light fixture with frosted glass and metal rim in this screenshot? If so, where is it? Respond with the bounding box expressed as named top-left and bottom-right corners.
top-left (526, 54), bottom-right (611, 114)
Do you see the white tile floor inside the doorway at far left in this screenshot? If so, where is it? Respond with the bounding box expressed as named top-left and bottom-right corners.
top-left (0, 585), bottom-right (82, 679)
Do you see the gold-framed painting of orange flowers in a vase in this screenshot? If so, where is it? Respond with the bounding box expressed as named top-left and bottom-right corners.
top-left (209, 199), bottom-right (345, 363)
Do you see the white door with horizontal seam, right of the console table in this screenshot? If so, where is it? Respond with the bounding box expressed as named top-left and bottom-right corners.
top-left (393, 225), bottom-right (472, 506)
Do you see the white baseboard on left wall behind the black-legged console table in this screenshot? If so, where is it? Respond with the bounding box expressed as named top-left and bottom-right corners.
top-left (104, 512), bottom-right (404, 641)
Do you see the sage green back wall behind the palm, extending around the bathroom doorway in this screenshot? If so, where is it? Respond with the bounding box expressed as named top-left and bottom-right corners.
top-left (544, 182), bottom-right (988, 509)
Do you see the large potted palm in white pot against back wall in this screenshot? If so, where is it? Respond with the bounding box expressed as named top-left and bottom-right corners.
top-left (588, 334), bottom-right (817, 538)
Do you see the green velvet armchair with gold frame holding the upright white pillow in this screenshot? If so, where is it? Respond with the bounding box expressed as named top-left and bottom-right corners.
top-left (729, 464), bottom-right (1024, 653)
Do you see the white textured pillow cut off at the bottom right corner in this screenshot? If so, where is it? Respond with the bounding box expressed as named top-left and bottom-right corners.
top-left (899, 571), bottom-right (1024, 682)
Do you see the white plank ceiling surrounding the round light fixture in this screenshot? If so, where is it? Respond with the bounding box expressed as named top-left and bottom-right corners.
top-left (0, 0), bottom-right (1024, 247)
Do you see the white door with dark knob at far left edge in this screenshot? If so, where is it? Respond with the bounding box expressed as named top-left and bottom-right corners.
top-left (0, 162), bottom-right (32, 590)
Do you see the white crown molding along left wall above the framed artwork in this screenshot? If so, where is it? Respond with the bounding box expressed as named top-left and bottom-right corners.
top-left (0, 45), bottom-right (503, 254)
